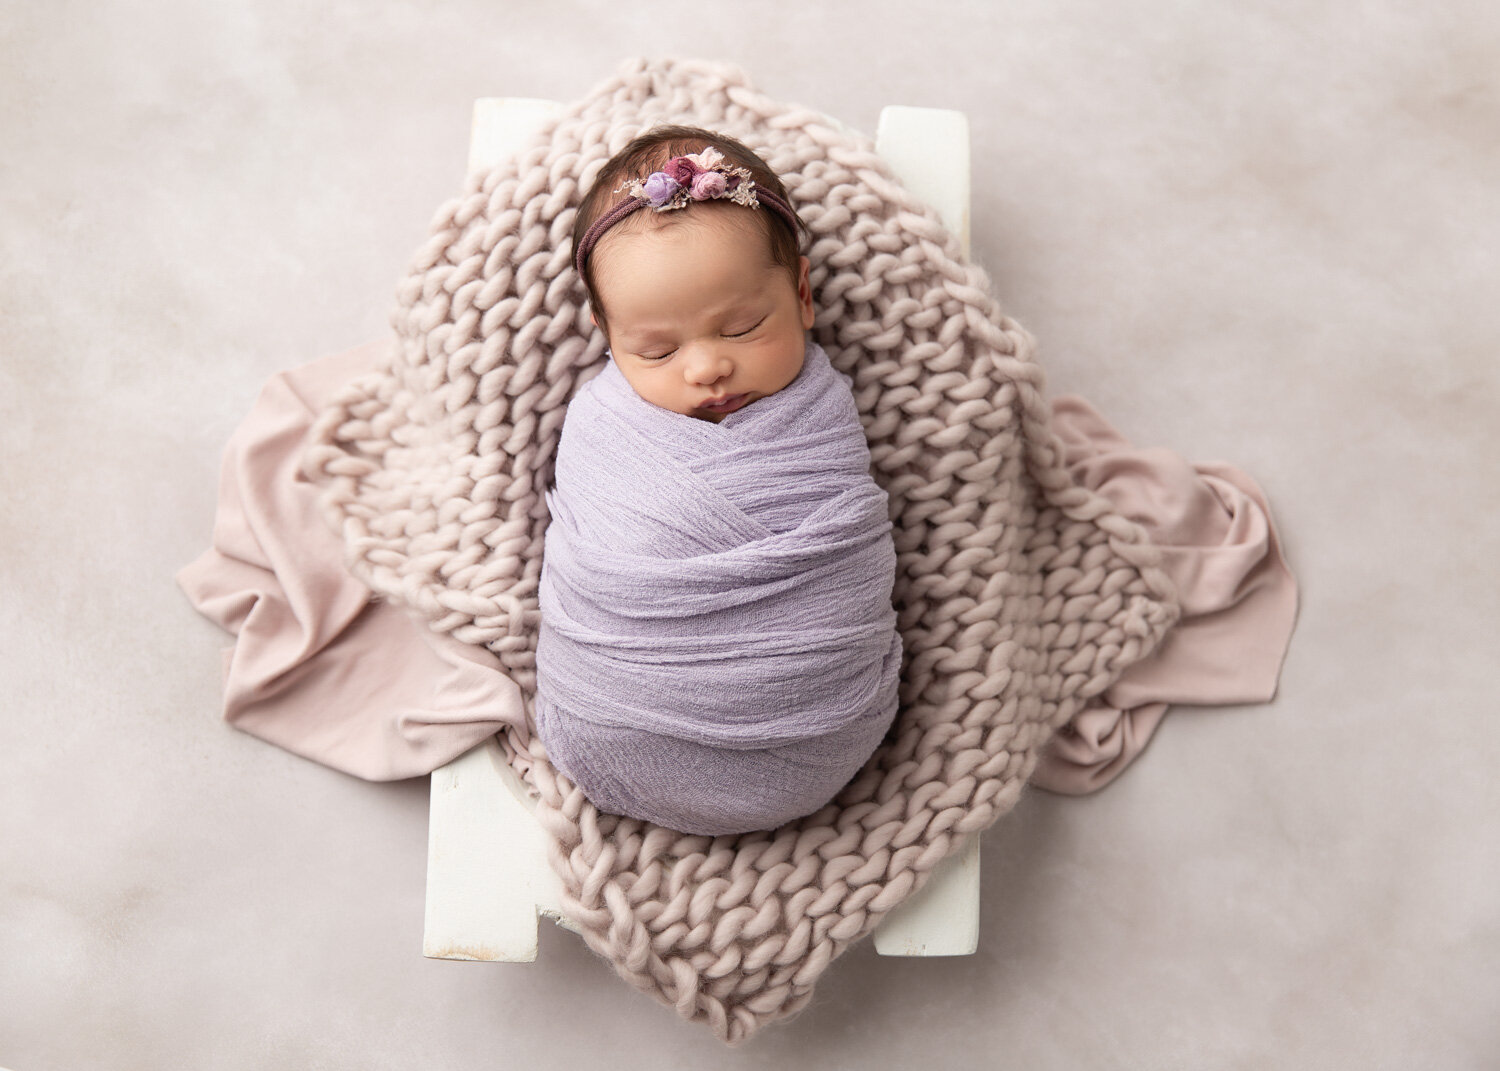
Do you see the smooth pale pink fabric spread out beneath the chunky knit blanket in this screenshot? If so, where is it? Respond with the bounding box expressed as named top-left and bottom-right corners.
top-left (177, 341), bottom-right (1298, 794)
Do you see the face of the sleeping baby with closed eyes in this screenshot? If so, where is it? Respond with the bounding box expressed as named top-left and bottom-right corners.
top-left (594, 204), bottom-right (813, 425)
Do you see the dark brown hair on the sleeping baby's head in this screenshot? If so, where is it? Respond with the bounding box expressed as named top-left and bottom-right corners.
top-left (573, 126), bottom-right (807, 329)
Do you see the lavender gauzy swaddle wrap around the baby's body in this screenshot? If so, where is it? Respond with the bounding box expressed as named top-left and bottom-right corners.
top-left (536, 338), bottom-right (902, 834)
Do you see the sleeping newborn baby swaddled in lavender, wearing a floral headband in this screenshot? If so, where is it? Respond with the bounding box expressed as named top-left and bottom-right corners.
top-left (536, 128), bottom-right (902, 834)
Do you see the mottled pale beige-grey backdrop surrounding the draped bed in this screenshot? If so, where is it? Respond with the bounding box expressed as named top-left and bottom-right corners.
top-left (0, 0), bottom-right (1500, 1071)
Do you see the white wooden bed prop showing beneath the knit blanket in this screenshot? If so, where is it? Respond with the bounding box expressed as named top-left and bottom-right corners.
top-left (422, 98), bottom-right (980, 963)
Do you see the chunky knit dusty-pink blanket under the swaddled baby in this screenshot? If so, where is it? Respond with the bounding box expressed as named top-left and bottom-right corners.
top-left (303, 60), bottom-right (1178, 1044)
